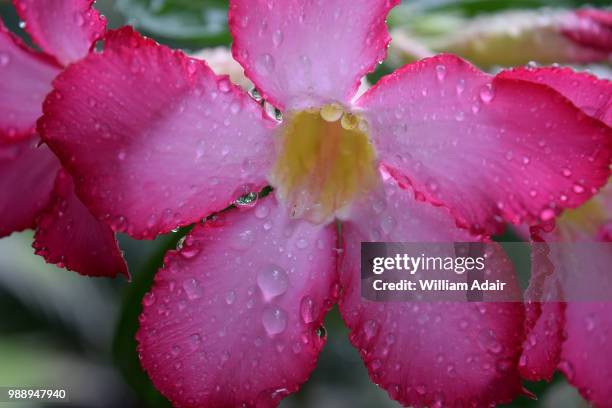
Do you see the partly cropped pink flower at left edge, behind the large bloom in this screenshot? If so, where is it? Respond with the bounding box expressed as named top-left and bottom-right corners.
top-left (0, 0), bottom-right (128, 276)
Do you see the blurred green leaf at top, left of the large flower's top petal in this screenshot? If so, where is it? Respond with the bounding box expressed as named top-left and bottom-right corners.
top-left (117, 0), bottom-right (231, 48)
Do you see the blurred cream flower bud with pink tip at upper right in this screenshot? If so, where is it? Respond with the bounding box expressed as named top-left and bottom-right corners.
top-left (391, 8), bottom-right (612, 68)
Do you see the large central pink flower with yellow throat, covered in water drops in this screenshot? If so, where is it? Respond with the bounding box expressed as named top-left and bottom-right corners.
top-left (34, 0), bottom-right (612, 406)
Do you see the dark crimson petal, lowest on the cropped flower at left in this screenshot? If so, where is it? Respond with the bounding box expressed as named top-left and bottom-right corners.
top-left (32, 170), bottom-right (129, 278)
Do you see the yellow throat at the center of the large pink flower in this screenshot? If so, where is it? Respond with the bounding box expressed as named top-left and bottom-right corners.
top-left (270, 104), bottom-right (377, 223)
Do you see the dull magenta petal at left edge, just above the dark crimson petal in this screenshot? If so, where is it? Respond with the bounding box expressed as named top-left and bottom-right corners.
top-left (0, 137), bottom-right (60, 237)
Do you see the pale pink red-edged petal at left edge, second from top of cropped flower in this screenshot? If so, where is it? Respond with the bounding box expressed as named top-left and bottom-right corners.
top-left (0, 20), bottom-right (60, 142)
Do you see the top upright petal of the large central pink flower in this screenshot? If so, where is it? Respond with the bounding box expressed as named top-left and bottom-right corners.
top-left (229, 0), bottom-right (399, 110)
